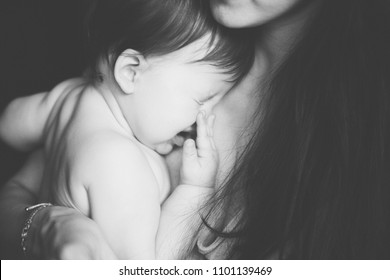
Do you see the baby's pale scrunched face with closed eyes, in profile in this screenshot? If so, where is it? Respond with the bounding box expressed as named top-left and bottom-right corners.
top-left (125, 37), bottom-right (233, 154)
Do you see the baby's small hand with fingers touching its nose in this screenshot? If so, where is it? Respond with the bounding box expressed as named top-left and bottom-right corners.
top-left (180, 112), bottom-right (218, 187)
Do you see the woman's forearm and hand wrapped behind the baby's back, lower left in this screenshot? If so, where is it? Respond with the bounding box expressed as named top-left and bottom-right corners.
top-left (0, 151), bottom-right (116, 259)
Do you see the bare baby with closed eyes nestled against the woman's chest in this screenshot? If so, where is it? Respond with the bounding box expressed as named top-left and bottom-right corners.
top-left (0, 0), bottom-right (252, 259)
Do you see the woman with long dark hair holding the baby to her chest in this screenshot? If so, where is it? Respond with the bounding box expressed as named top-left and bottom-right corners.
top-left (0, 0), bottom-right (390, 259)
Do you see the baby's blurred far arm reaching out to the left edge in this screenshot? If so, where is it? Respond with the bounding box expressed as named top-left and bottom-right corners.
top-left (0, 81), bottom-right (73, 151)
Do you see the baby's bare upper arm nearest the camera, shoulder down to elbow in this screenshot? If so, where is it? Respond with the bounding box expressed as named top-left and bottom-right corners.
top-left (78, 135), bottom-right (160, 259)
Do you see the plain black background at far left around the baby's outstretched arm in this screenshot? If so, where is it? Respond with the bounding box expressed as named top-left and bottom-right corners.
top-left (0, 0), bottom-right (87, 185)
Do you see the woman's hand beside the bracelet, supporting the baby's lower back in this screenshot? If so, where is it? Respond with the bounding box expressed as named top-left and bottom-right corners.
top-left (27, 206), bottom-right (116, 260)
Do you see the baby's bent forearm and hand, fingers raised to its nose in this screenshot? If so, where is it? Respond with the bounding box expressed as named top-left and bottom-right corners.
top-left (157, 113), bottom-right (218, 259)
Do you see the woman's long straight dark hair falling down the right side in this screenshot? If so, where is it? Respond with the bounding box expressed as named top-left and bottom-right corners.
top-left (200, 0), bottom-right (390, 259)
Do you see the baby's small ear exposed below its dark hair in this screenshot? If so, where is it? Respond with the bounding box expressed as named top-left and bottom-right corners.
top-left (114, 49), bottom-right (147, 94)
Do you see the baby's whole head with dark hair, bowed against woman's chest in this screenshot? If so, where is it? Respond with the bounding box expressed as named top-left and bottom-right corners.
top-left (87, 0), bottom-right (253, 154)
